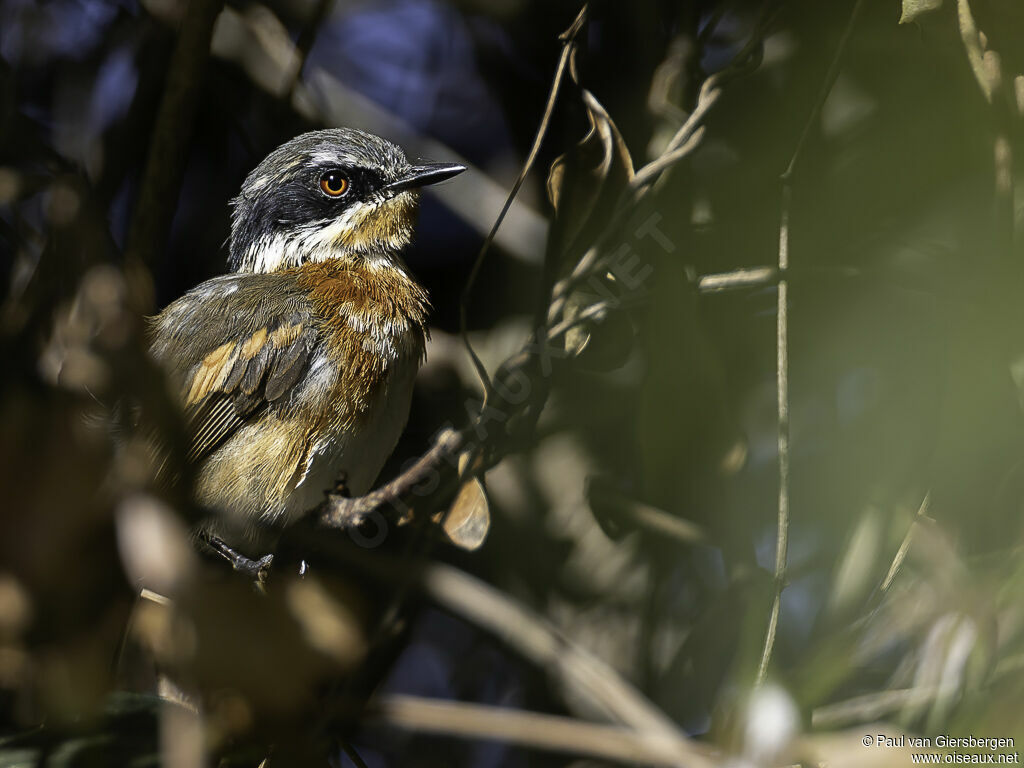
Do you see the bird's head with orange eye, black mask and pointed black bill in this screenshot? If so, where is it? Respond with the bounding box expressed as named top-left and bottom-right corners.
top-left (229, 128), bottom-right (465, 272)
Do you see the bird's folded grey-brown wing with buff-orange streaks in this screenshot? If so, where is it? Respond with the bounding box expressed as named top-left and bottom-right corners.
top-left (151, 274), bottom-right (318, 462)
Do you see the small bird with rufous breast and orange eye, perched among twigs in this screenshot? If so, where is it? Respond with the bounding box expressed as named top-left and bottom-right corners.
top-left (150, 128), bottom-right (465, 551)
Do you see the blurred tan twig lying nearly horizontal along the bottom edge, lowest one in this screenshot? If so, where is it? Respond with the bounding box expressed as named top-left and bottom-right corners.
top-left (371, 695), bottom-right (712, 766)
